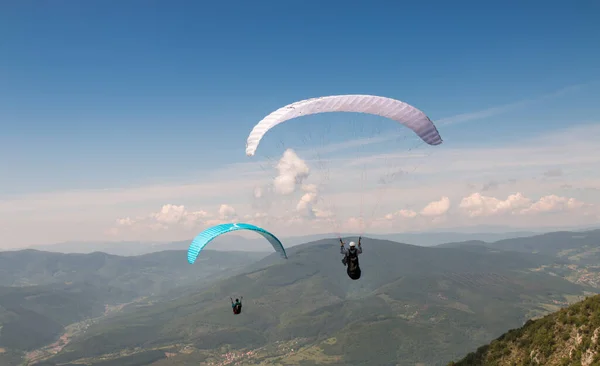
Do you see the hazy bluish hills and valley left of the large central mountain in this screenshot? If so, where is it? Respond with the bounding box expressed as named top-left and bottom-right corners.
top-left (0, 246), bottom-right (264, 364)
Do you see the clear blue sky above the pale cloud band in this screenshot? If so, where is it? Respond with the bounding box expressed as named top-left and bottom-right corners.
top-left (0, 0), bottom-right (600, 246)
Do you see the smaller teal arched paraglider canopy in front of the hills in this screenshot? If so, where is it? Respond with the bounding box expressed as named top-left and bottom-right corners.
top-left (188, 223), bottom-right (287, 264)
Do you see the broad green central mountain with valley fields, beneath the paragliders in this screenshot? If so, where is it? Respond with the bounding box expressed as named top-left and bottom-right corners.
top-left (36, 239), bottom-right (593, 365)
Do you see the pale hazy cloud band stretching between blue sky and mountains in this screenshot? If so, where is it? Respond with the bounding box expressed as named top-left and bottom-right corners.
top-left (0, 124), bottom-right (600, 248)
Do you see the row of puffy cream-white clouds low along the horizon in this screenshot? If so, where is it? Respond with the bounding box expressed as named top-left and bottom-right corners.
top-left (110, 192), bottom-right (600, 243)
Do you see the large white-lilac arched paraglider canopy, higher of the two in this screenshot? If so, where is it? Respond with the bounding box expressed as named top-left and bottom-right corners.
top-left (246, 95), bottom-right (442, 156)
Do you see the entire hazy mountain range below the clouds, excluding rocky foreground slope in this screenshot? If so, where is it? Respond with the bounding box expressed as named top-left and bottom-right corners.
top-left (0, 230), bottom-right (600, 366)
